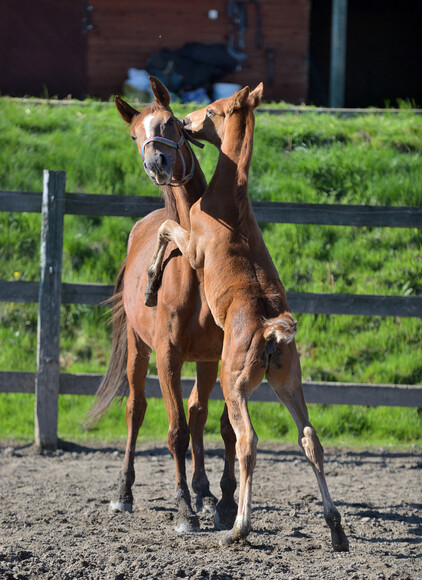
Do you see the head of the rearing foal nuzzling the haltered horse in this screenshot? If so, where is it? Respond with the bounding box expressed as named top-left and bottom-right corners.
top-left (182, 83), bottom-right (264, 148)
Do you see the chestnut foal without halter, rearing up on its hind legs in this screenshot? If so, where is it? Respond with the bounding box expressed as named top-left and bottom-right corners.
top-left (146, 84), bottom-right (349, 551)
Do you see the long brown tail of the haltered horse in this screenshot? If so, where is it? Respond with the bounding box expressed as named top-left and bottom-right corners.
top-left (85, 260), bottom-right (128, 429)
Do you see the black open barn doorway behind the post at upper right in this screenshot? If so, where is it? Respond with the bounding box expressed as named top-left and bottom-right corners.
top-left (309, 0), bottom-right (422, 107)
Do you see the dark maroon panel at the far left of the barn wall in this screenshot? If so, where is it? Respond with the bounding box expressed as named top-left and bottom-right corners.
top-left (0, 0), bottom-right (86, 98)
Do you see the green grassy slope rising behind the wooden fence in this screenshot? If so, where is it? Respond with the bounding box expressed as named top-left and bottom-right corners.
top-left (0, 98), bottom-right (422, 442)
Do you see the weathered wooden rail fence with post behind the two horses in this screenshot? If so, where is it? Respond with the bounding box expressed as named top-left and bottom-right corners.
top-left (0, 170), bottom-right (422, 448)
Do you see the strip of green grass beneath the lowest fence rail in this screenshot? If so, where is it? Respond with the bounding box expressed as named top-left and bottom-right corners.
top-left (0, 393), bottom-right (422, 447)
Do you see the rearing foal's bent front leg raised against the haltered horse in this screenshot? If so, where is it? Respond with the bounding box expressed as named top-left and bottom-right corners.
top-left (145, 220), bottom-right (189, 306)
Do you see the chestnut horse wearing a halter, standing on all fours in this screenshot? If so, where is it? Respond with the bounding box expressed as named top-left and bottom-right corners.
top-left (88, 77), bottom-right (229, 531)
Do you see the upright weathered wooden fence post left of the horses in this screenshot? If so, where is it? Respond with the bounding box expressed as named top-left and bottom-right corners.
top-left (35, 169), bottom-right (66, 449)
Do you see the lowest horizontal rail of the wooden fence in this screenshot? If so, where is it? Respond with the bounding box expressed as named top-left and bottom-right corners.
top-left (0, 371), bottom-right (422, 408)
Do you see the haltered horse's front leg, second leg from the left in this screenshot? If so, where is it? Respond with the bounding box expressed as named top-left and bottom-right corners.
top-left (157, 337), bottom-right (199, 532)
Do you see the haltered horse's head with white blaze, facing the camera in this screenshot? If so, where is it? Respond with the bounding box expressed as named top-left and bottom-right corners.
top-left (115, 76), bottom-right (184, 185)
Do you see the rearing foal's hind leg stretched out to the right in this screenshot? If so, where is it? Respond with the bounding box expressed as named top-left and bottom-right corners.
top-left (267, 343), bottom-right (349, 552)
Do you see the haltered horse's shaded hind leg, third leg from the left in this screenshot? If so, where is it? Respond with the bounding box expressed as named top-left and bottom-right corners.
top-left (188, 361), bottom-right (218, 514)
